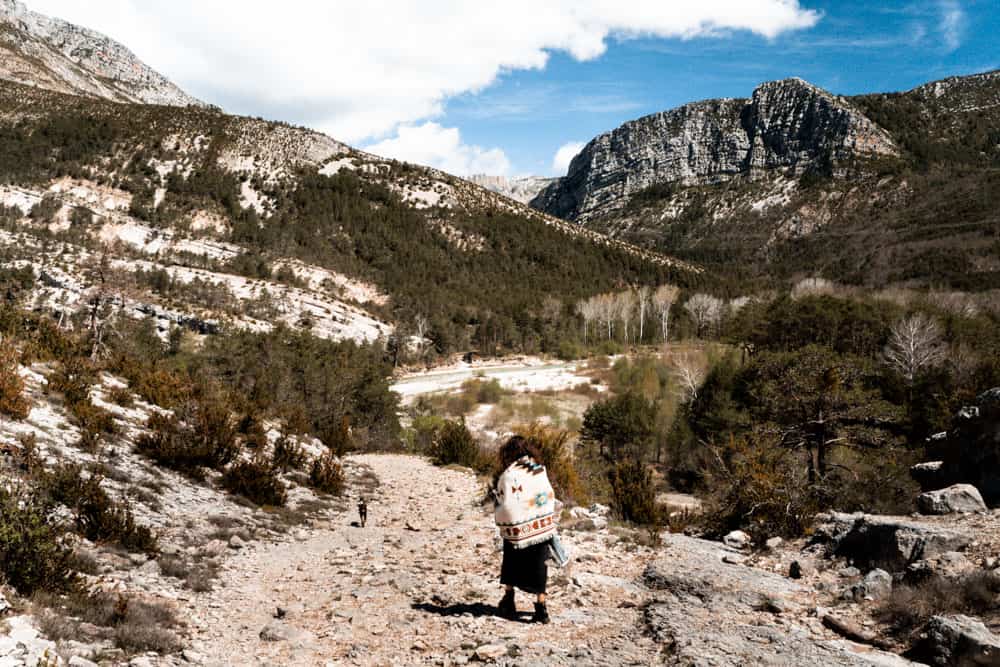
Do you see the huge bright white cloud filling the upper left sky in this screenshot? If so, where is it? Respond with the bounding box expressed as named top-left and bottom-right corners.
top-left (27, 0), bottom-right (819, 142)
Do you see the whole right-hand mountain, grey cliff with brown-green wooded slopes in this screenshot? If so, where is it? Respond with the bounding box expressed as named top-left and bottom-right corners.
top-left (531, 72), bottom-right (1000, 290)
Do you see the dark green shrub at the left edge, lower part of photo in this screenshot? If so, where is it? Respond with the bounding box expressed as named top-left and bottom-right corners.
top-left (0, 486), bottom-right (76, 595)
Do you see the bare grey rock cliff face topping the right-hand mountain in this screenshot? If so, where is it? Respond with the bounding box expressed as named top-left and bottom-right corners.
top-left (532, 79), bottom-right (896, 222)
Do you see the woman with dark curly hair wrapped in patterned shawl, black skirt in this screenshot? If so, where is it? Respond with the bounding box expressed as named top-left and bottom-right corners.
top-left (493, 435), bottom-right (561, 623)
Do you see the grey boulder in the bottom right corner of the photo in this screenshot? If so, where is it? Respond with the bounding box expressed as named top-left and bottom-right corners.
top-left (908, 616), bottom-right (1000, 667)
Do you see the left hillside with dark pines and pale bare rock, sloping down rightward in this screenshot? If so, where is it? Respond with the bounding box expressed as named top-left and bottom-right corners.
top-left (0, 83), bottom-right (699, 358)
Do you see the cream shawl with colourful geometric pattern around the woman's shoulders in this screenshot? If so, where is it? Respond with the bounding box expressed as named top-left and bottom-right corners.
top-left (495, 456), bottom-right (556, 549)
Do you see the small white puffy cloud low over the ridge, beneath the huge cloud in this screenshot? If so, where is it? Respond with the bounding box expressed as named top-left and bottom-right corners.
top-left (365, 123), bottom-right (510, 176)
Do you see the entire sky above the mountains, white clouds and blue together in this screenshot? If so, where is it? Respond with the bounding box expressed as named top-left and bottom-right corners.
top-left (25, 0), bottom-right (1000, 177)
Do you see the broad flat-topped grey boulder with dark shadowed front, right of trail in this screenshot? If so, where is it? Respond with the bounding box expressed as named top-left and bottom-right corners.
top-left (816, 512), bottom-right (972, 572)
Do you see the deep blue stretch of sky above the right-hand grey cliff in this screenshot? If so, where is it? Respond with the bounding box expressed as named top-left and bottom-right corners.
top-left (450, 0), bottom-right (1000, 174)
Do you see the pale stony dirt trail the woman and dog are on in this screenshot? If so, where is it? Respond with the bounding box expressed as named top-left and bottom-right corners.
top-left (184, 455), bottom-right (659, 665)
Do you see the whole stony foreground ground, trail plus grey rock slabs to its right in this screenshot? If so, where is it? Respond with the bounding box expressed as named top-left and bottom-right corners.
top-left (181, 455), bottom-right (906, 665)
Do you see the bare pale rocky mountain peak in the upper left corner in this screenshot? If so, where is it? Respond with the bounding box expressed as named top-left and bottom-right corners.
top-left (0, 0), bottom-right (202, 106)
